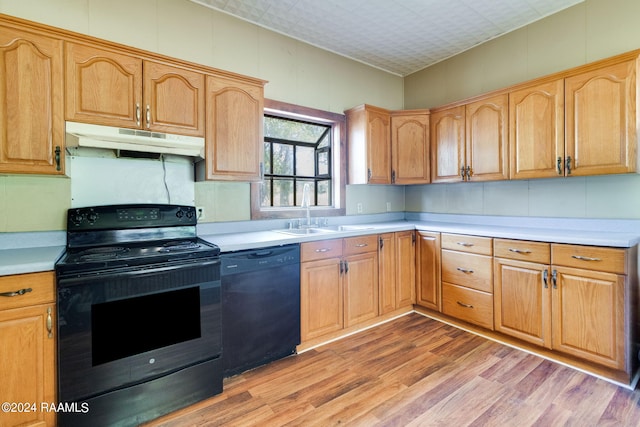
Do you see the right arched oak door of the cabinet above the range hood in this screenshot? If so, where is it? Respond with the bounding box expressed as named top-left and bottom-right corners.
top-left (144, 61), bottom-right (205, 136)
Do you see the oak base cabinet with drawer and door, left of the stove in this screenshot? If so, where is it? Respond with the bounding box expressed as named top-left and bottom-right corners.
top-left (0, 272), bottom-right (56, 426)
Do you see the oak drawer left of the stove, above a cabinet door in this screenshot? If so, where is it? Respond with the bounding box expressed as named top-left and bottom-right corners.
top-left (0, 271), bottom-right (55, 310)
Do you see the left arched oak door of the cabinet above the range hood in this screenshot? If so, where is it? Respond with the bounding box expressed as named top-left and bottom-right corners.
top-left (65, 43), bottom-right (143, 128)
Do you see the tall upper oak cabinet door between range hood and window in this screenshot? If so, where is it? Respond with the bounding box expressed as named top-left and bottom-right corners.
top-left (205, 76), bottom-right (264, 181)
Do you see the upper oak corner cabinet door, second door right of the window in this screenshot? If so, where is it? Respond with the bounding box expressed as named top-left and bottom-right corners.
top-left (391, 112), bottom-right (431, 184)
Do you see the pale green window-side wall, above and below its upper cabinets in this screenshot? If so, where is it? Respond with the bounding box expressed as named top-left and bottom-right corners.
top-left (0, 0), bottom-right (404, 232)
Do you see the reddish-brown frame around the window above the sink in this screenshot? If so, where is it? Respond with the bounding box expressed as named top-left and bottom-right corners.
top-left (250, 99), bottom-right (347, 219)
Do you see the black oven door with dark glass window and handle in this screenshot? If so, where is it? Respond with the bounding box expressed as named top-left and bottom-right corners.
top-left (58, 258), bottom-right (222, 402)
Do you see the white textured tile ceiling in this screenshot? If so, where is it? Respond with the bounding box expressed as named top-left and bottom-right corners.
top-left (191, 0), bottom-right (584, 76)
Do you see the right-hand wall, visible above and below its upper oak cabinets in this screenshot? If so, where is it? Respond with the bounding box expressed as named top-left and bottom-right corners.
top-left (405, 0), bottom-right (640, 219)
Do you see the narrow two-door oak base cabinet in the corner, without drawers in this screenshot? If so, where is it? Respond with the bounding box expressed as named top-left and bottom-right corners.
top-left (378, 230), bottom-right (416, 314)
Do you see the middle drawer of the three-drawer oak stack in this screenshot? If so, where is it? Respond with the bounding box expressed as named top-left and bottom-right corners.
top-left (442, 250), bottom-right (493, 293)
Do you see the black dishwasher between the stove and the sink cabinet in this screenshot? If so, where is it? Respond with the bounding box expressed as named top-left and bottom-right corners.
top-left (220, 245), bottom-right (300, 377)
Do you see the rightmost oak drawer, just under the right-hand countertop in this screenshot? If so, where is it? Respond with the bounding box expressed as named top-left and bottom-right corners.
top-left (551, 244), bottom-right (627, 274)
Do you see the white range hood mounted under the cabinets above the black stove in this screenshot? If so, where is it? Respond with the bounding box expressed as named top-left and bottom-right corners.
top-left (65, 122), bottom-right (204, 160)
